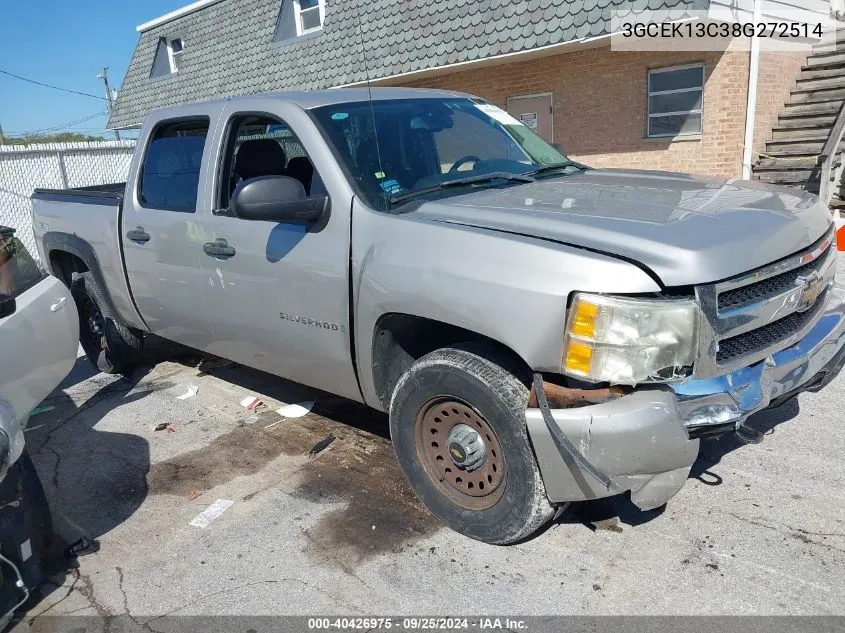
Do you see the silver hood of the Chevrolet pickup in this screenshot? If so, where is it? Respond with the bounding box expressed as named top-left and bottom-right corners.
top-left (410, 169), bottom-right (831, 286)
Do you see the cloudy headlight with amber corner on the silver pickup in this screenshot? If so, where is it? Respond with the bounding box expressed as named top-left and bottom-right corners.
top-left (563, 293), bottom-right (698, 385)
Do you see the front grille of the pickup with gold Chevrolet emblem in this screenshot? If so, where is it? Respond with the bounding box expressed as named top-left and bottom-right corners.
top-left (694, 228), bottom-right (836, 378)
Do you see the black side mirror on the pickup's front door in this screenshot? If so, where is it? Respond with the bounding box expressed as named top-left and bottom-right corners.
top-left (231, 176), bottom-right (330, 224)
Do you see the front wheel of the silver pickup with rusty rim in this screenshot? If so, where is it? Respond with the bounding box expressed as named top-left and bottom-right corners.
top-left (390, 346), bottom-right (554, 545)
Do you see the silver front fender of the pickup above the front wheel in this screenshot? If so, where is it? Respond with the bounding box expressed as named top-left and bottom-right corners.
top-left (352, 207), bottom-right (660, 408)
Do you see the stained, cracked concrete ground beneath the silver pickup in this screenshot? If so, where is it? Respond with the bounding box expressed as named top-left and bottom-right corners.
top-left (11, 320), bottom-right (845, 630)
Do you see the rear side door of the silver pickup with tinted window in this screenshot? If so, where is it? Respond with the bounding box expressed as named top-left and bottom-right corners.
top-left (121, 116), bottom-right (213, 349)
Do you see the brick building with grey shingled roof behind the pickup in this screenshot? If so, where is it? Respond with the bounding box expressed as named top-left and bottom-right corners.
top-left (110, 0), bottom-right (828, 183)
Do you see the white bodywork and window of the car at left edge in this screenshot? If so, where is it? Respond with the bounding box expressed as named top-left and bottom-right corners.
top-left (0, 226), bottom-right (79, 480)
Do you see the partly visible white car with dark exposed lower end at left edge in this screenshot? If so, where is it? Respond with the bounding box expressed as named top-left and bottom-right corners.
top-left (0, 226), bottom-right (79, 629)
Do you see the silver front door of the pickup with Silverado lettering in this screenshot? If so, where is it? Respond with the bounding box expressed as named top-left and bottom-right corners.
top-left (202, 102), bottom-right (361, 400)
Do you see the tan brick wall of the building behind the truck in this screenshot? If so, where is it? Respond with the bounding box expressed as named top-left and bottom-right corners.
top-left (402, 41), bottom-right (800, 178)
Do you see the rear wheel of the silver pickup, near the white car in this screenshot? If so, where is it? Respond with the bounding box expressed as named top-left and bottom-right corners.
top-left (71, 272), bottom-right (144, 374)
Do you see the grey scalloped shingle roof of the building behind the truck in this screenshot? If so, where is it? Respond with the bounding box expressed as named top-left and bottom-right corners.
top-left (109, 0), bottom-right (709, 128)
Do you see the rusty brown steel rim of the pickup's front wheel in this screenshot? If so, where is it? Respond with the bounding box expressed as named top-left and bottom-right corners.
top-left (415, 396), bottom-right (507, 510)
